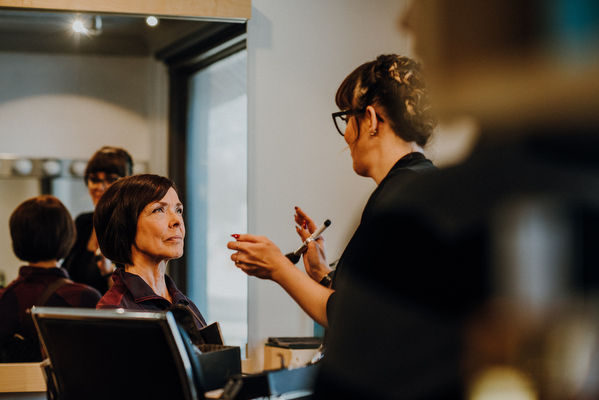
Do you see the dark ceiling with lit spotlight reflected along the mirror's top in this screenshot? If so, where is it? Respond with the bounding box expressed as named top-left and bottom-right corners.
top-left (0, 10), bottom-right (213, 56)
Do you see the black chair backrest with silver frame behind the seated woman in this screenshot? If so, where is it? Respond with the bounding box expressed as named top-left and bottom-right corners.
top-left (32, 307), bottom-right (204, 400)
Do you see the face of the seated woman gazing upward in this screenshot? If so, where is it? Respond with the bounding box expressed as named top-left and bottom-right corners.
top-left (132, 188), bottom-right (185, 262)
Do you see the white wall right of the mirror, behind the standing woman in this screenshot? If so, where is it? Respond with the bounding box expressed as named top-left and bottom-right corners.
top-left (248, 0), bottom-right (408, 370)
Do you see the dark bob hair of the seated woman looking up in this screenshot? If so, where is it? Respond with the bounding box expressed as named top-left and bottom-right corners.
top-left (94, 174), bottom-right (179, 265)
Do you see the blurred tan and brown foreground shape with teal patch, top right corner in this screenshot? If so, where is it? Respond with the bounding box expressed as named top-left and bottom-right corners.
top-left (402, 0), bottom-right (599, 129)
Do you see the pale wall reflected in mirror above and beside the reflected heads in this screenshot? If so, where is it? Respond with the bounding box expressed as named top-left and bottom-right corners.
top-left (0, 53), bottom-right (168, 282)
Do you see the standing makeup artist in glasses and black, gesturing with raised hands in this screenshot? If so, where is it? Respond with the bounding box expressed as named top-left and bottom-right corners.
top-left (227, 54), bottom-right (436, 328)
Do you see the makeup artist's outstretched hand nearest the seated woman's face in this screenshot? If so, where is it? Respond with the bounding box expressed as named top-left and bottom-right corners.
top-left (227, 234), bottom-right (295, 282)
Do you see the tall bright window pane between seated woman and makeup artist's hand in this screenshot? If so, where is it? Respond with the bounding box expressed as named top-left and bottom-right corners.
top-left (185, 50), bottom-right (247, 348)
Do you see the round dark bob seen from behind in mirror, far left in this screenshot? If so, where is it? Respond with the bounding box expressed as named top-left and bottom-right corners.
top-left (9, 195), bottom-right (75, 263)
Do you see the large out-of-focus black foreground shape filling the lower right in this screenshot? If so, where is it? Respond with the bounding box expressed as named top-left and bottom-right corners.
top-left (315, 131), bottom-right (599, 400)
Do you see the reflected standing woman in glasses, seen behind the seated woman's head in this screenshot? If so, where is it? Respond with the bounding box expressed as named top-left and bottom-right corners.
top-left (63, 146), bottom-right (133, 294)
